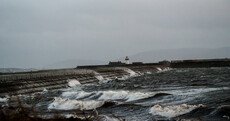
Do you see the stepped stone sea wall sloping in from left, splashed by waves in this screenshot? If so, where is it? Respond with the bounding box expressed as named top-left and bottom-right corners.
top-left (0, 66), bottom-right (166, 97)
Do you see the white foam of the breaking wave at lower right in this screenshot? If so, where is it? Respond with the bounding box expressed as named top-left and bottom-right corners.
top-left (150, 104), bottom-right (203, 118)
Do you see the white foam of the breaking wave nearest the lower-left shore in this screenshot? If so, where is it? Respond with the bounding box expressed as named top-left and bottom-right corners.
top-left (48, 97), bottom-right (104, 110)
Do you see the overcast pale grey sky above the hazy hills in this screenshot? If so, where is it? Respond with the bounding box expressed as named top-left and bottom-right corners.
top-left (0, 0), bottom-right (230, 68)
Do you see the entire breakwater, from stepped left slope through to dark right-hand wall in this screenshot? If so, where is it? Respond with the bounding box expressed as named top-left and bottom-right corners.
top-left (0, 59), bottom-right (230, 96)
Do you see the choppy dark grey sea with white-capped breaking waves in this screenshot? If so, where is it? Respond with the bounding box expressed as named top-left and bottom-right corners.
top-left (0, 68), bottom-right (230, 121)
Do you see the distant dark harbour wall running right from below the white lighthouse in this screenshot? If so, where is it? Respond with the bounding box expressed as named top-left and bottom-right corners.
top-left (77, 58), bottom-right (230, 69)
